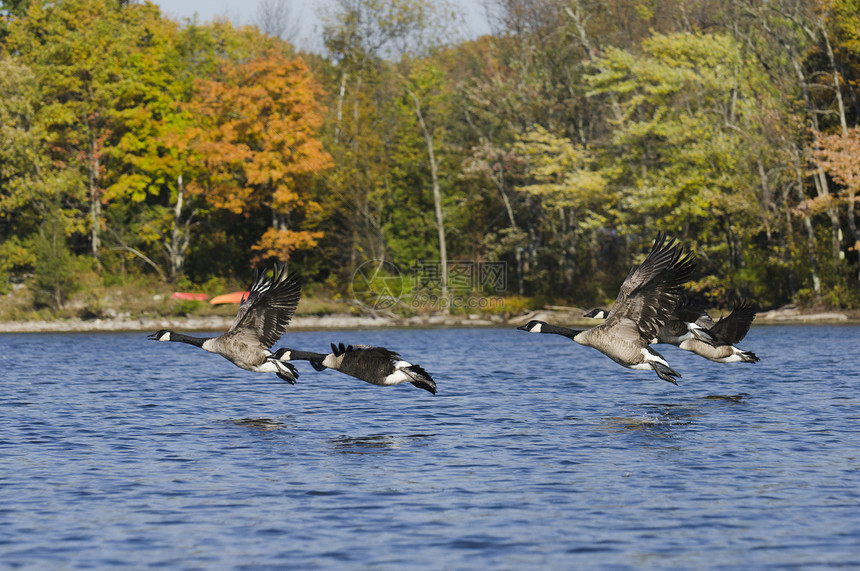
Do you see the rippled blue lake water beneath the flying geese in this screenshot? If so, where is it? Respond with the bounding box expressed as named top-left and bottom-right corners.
top-left (0, 326), bottom-right (860, 569)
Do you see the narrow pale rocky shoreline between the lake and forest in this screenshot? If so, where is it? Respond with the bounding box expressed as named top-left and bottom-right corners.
top-left (0, 305), bottom-right (860, 333)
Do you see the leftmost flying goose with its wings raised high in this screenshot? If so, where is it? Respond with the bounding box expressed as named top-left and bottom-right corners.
top-left (148, 262), bottom-right (301, 384)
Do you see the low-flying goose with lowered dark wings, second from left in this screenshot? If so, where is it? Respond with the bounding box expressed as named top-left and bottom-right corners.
top-left (275, 343), bottom-right (436, 395)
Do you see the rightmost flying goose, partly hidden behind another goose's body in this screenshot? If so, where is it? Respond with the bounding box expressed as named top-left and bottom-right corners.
top-left (585, 300), bottom-right (759, 363)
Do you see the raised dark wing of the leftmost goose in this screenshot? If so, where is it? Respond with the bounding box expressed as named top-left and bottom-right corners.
top-left (225, 262), bottom-right (302, 347)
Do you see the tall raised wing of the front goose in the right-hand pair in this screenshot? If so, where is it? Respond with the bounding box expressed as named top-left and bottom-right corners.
top-left (597, 233), bottom-right (696, 343)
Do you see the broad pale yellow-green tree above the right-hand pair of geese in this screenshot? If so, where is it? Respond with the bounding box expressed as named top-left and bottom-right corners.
top-left (588, 30), bottom-right (776, 298)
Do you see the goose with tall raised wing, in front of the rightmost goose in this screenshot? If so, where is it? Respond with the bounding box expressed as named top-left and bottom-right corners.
top-left (518, 233), bottom-right (696, 384)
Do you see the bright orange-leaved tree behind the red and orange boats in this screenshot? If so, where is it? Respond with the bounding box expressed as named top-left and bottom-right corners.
top-left (186, 50), bottom-right (332, 262)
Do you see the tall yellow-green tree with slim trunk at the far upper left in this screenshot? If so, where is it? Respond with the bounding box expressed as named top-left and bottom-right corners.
top-left (8, 0), bottom-right (157, 257)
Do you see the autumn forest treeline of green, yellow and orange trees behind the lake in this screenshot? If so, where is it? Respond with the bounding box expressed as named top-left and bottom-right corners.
top-left (0, 0), bottom-right (860, 307)
